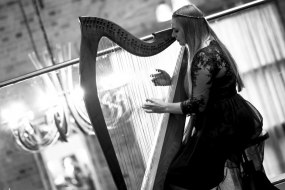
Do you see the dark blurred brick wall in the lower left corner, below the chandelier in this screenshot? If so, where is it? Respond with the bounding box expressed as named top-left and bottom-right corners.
top-left (0, 130), bottom-right (44, 190)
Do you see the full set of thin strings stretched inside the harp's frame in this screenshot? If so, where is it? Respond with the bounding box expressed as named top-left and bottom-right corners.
top-left (96, 38), bottom-right (180, 189)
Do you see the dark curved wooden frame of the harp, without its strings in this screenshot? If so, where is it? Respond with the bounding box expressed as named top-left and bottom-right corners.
top-left (79, 17), bottom-right (186, 190)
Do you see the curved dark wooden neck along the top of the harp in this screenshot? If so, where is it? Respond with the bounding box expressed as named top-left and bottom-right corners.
top-left (79, 17), bottom-right (175, 57)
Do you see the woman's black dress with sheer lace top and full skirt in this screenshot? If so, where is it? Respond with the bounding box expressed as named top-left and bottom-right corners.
top-left (165, 40), bottom-right (262, 190)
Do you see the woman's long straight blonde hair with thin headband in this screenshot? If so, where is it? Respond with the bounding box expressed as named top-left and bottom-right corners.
top-left (172, 4), bottom-right (244, 91)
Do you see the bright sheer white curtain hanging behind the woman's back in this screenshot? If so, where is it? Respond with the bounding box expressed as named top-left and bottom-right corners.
top-left (206, 3), bottom-right (285, 189)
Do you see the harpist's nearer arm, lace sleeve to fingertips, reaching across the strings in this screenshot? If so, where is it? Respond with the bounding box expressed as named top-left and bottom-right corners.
top-left (143, 52), bottom-right (219, 115)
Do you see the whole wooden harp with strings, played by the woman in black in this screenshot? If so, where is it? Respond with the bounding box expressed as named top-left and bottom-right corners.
top-left (79, 17), bottom-right (187, 190)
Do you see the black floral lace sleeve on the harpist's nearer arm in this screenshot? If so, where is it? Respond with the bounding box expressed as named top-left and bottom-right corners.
top-left (180, 52), bottom-right (220, 115)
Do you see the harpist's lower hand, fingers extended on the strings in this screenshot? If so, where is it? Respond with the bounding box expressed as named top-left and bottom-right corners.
top-left (142, 99), bottom-right (167, 113)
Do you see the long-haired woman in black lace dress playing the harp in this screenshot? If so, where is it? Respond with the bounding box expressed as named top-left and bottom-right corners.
top-left (143, 5), bottom-right (262, 190)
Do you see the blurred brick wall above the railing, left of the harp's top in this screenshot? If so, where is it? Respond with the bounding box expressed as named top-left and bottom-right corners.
top-left (0, 0), bottom-right (161, 81)
